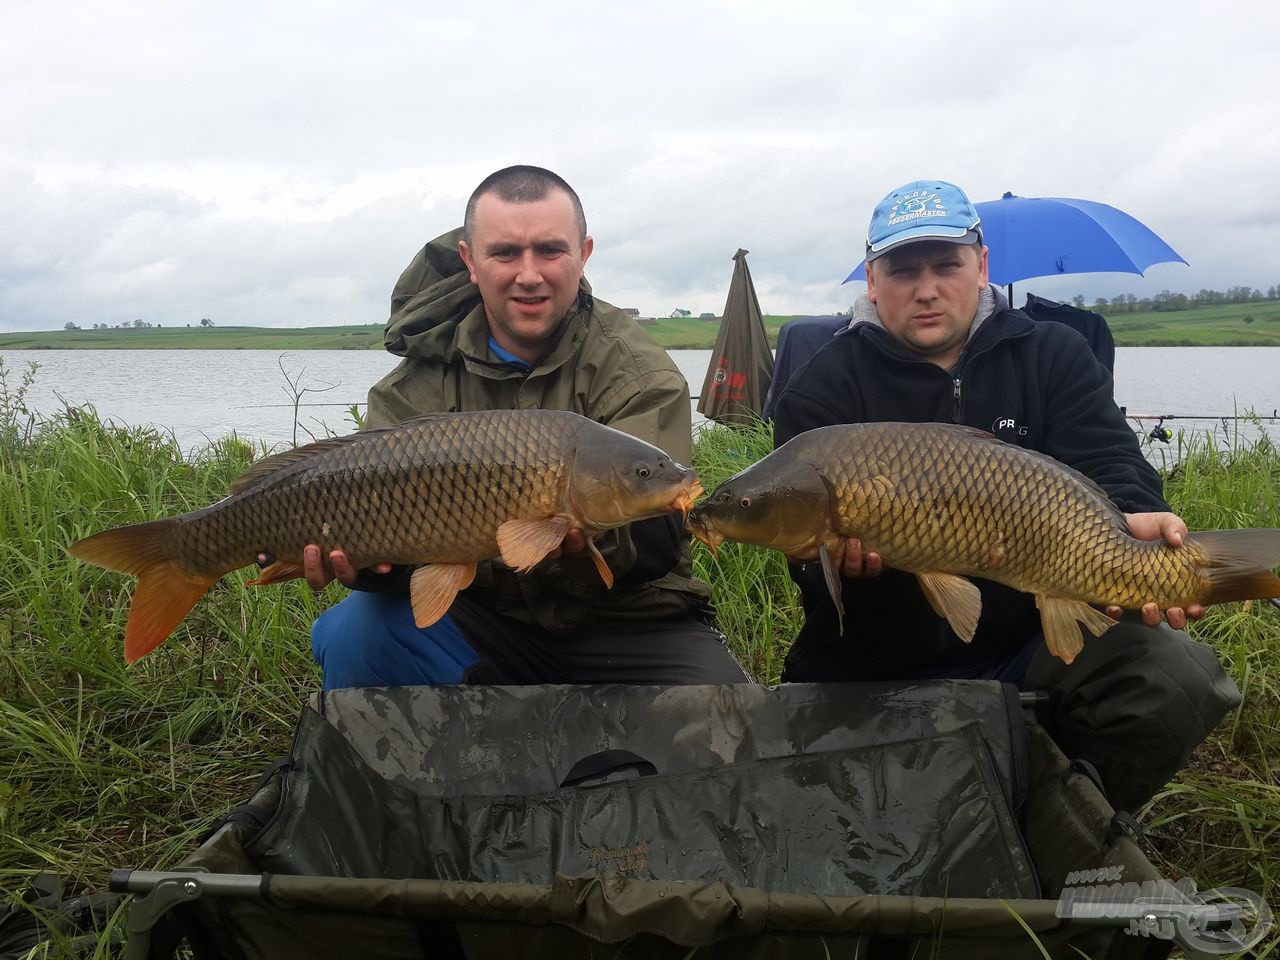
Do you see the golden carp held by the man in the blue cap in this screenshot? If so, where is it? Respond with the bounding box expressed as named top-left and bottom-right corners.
top-left (689, 424), bottom-right (1280, 663)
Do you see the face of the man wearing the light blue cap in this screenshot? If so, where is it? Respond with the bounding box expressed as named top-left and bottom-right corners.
top-left (867, 241), bottom-right (987, 367)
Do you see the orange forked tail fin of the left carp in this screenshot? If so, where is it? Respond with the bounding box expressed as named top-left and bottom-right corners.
top-left (70, 520), bottom-right (221, 663)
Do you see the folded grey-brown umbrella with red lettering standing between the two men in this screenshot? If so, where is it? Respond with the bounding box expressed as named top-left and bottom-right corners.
top-left (698, 250), bottom-right (773, 424)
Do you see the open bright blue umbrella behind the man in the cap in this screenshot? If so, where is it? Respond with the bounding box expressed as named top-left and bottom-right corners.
top-left (845, 193), bottom-right (1187, 285)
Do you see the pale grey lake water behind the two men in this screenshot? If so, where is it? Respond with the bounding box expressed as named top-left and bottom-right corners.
top-left (0, 347), bottom-right (1280, 451)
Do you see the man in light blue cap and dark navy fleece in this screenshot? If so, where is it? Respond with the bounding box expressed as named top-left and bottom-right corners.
top-left (774, 180), bottom-right (1239, 810)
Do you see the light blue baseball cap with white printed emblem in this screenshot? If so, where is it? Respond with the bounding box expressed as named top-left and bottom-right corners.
top-left (867, 180), bottom-right (982, 261)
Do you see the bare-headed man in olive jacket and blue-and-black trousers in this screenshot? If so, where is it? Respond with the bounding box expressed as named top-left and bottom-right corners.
top-left (306, 166), bottom-right (746, 689)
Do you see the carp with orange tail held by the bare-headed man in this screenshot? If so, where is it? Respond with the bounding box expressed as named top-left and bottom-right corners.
top-left (70, 410), bottom-right (703, 662)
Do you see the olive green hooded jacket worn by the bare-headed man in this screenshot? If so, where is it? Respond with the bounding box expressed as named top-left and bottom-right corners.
top-left (366, 228), bottom-right (710, 632)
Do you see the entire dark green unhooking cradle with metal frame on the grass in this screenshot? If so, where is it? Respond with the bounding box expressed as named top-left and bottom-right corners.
top-left (132, 681), bottom-right (1169, 960)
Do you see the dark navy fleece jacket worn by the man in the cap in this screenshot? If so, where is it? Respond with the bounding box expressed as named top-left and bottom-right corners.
top-left (774, 297), bottom-right (1169, 681)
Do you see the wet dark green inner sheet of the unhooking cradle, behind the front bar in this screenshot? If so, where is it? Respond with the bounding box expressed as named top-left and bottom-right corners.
top-left (248, 684), bottom-right (1037, 897)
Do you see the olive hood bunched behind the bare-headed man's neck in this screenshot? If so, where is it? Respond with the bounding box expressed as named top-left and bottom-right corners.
top-left (383, 227), bottom-right (591, 357)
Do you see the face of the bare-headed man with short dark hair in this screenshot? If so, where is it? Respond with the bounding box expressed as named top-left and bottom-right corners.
top-left (458, 189), bottom-right (593, 364)
